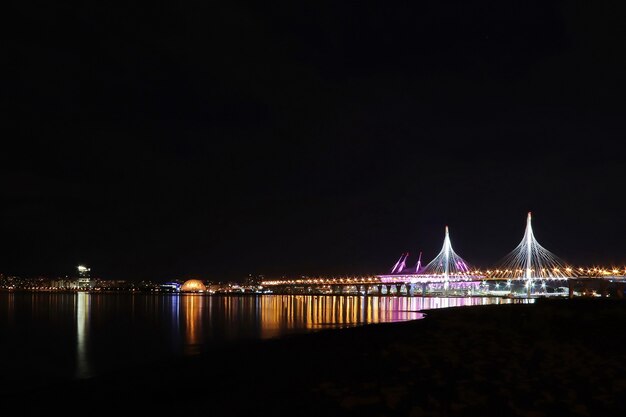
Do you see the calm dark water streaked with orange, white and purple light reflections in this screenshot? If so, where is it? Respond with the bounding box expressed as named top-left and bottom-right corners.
top-left (0, 292), bottom-right (532, 388)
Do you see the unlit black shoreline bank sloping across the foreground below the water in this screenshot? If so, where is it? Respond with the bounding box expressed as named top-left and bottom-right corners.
top-left (2, 299), bottom-right (626, 416)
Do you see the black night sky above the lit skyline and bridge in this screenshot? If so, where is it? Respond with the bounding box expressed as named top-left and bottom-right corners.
top-left (0, 0), bottom-right (626, 280)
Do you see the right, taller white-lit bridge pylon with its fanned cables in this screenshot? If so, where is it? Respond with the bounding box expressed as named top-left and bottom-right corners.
top-left (494, 212), bottom-right (574, 294)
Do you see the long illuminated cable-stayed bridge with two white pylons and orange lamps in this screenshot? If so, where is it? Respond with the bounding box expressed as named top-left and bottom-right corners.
top-left (263, 213), bottom-right (626, 297)
